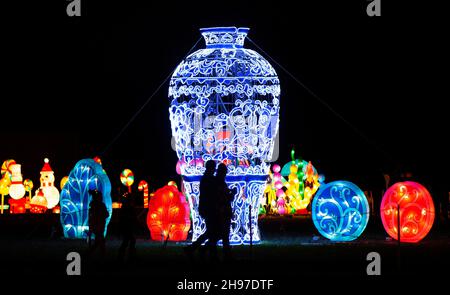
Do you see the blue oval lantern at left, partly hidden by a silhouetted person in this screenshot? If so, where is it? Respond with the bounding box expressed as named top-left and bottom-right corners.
top-left (60, 159), bottom-right (112, 239)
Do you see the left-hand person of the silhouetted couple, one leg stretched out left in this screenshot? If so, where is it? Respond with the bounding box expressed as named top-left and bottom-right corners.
top-left (184, 160), bottom-right (218, 258)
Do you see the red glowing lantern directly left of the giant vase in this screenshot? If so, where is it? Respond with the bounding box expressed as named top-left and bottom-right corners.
top-left (147, 185), bottom-right (191, 241)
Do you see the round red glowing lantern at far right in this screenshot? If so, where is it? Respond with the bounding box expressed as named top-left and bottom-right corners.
top-left (380, 181), bottom-right (435, 243)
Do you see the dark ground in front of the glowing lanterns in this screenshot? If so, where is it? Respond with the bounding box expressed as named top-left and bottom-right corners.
top-left (0, 217), bottom-right (450, 279)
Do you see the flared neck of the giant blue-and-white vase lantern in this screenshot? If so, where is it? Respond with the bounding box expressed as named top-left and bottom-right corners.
top-left (200, 27), bottom-right (250, 48)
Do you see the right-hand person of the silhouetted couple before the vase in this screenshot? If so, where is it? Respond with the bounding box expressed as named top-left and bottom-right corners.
top-left (216, 163), bottom-right (234, 260)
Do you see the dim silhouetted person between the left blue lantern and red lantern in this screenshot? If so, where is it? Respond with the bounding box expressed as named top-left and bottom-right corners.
top-left (119, 193), bottom-right (137, 262)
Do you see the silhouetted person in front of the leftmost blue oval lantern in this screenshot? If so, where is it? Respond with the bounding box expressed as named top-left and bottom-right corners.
top-left (89, 190), bottom-right (109, 258)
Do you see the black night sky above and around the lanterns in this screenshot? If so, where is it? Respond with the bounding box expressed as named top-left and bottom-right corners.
top-left (0, 0), bottom-right (449, 197)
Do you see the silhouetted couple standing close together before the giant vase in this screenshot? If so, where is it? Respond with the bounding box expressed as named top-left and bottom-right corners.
top-left (185, 160), bottom-right (233, 260)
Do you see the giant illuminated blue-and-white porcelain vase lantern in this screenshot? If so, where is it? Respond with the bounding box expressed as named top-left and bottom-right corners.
top-left (169, 27), bottom-right (280, 244)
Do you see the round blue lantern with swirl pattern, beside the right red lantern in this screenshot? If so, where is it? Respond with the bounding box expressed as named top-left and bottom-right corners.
top-left (312, 181), bottom-right (370, 242)
